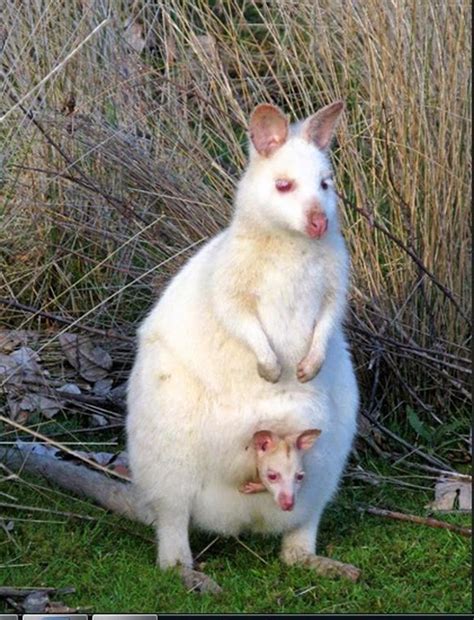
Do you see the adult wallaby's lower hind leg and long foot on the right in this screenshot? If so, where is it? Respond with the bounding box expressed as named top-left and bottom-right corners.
top-left (280, 515), bottom-right (360, 581)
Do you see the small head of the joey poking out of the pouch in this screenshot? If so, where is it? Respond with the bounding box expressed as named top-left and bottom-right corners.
top-left (252, 428), bottom-right (321, 510)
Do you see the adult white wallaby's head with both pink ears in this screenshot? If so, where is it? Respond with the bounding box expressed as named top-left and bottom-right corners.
top-left (237, 101), bottom-right (344, 239)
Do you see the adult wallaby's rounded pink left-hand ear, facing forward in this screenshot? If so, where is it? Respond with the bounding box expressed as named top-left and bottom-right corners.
top-left (249, 103), bottom-right (288, 157)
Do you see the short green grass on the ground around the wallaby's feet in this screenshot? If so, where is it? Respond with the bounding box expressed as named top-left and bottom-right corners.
top-left (0, 470), bottom-right (472, 613)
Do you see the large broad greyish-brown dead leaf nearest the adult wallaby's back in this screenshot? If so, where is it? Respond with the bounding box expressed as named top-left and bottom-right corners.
top-left (59, 333), bottom-right (113, 383)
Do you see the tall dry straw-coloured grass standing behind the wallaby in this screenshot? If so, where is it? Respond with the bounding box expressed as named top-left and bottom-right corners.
top-left (0, 0), bottom-right (471, 456)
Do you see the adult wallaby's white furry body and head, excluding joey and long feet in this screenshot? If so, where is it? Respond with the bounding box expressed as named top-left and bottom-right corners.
top-left (127, 102), bottom-right (358, 580)
